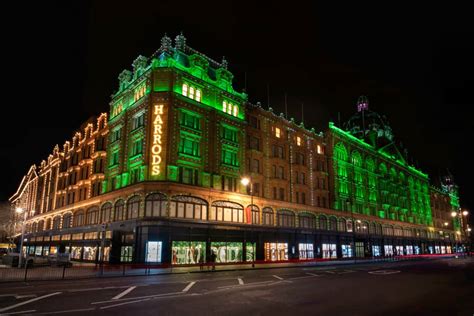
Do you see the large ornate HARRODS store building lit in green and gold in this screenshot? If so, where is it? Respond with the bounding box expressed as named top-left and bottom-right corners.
top-left (10, 35), bottom-right (461, 264)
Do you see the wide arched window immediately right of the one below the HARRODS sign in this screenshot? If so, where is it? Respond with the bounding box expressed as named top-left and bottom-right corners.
top-left (170, 195), bottom-right (207, 220)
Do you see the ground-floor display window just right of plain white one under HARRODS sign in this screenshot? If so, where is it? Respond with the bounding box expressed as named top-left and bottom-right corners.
top-left (171, 241), bottom-right (206, 264)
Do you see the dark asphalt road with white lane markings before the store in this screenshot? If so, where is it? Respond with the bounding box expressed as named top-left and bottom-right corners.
top-left (0, 258), bottom-right (474, 316)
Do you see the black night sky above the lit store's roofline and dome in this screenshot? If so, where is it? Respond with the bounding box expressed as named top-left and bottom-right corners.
top-left (0, 0), bottom-right (474, 217)
